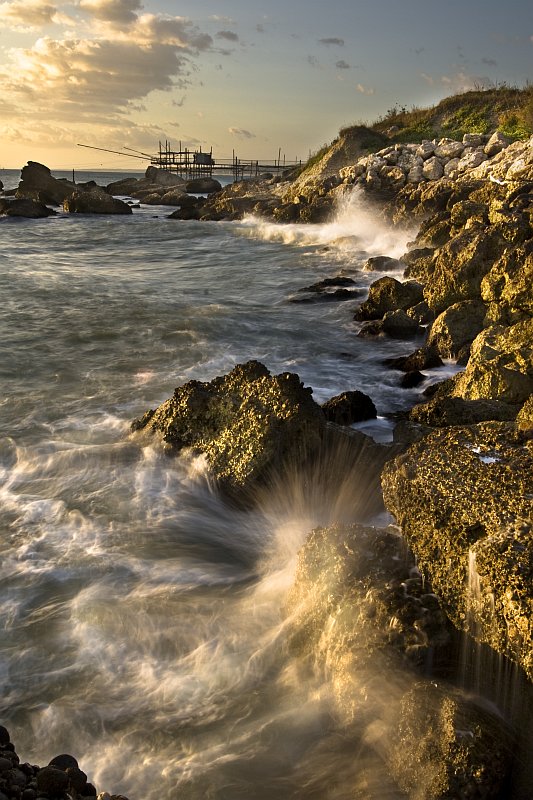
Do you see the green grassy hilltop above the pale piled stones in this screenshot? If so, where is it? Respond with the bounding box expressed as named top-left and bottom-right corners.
top-left (366, 85), bottom-right (533, 142)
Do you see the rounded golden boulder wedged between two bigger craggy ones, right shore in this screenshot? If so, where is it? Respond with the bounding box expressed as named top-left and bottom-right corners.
top-left (428, 300), bottom-right (487, 358)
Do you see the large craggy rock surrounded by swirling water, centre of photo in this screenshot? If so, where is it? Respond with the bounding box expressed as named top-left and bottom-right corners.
top-left (134, 361), bottom-right (326, 493)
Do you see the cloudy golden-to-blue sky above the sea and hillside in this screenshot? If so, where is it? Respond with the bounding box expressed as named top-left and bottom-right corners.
top-left (0, 0), bottom-right (533, 170)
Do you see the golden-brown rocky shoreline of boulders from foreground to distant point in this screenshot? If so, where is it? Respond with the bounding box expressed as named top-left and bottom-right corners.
top-left (0, 131), bottom-right (533, 800)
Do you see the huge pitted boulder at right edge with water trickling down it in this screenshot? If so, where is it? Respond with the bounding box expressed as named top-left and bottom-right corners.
top-left (382, 422), bottom-right (533, 679)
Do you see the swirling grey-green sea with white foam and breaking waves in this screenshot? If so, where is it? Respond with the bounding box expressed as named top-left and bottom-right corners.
top-left (0, 166), bottom-right (455, 800)
